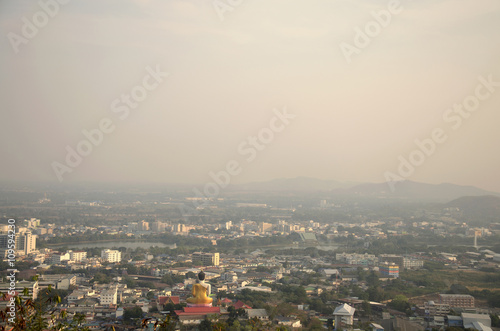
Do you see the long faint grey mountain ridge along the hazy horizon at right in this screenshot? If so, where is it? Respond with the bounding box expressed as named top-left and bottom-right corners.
top-left (232, 177), bottom-right (500, 203)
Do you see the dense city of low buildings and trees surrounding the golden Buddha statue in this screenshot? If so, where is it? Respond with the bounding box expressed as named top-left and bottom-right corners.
top-left (0, 183), bottom-right (500, 331)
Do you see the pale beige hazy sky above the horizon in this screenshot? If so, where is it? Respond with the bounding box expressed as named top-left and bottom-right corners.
top-left (0, 0), bottom-right (500, 191)
